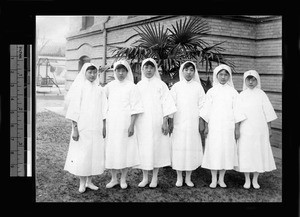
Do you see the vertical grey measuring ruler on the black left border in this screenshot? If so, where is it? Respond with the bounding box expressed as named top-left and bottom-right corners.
top-left (10, 45), bottom-right (31, 176)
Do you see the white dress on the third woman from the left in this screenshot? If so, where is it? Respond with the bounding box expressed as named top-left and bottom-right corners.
top-left (136, 76), bottom-right (176, 170)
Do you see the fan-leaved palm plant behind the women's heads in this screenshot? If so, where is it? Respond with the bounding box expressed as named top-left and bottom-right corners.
top-left (110, 16), bottom-right (234, 91)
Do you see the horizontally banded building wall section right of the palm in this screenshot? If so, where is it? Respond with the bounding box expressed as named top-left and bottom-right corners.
top-left (200, 16), bottom-right (282, 148)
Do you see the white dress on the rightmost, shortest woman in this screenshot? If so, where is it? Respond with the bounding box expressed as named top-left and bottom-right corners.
top-left (236, 88), bottom-right (277, 172)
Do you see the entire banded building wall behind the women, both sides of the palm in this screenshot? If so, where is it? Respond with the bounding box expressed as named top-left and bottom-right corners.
top-left (66, 15), bottom-right (282, 148)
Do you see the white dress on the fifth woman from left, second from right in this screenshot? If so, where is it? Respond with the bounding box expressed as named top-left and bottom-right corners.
top-left (200, 84), bottom-right (244, 170)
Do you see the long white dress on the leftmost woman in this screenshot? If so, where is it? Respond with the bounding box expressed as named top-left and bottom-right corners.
top-left (64, 80), bottom-right (107, 176)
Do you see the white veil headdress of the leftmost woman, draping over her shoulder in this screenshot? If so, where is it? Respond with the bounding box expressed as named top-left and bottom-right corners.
top-left (64, 63), bottom-right (99, 112)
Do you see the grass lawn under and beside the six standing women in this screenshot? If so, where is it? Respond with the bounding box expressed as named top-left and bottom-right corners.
top-left (36, 111), bottom-right (282, 202)
